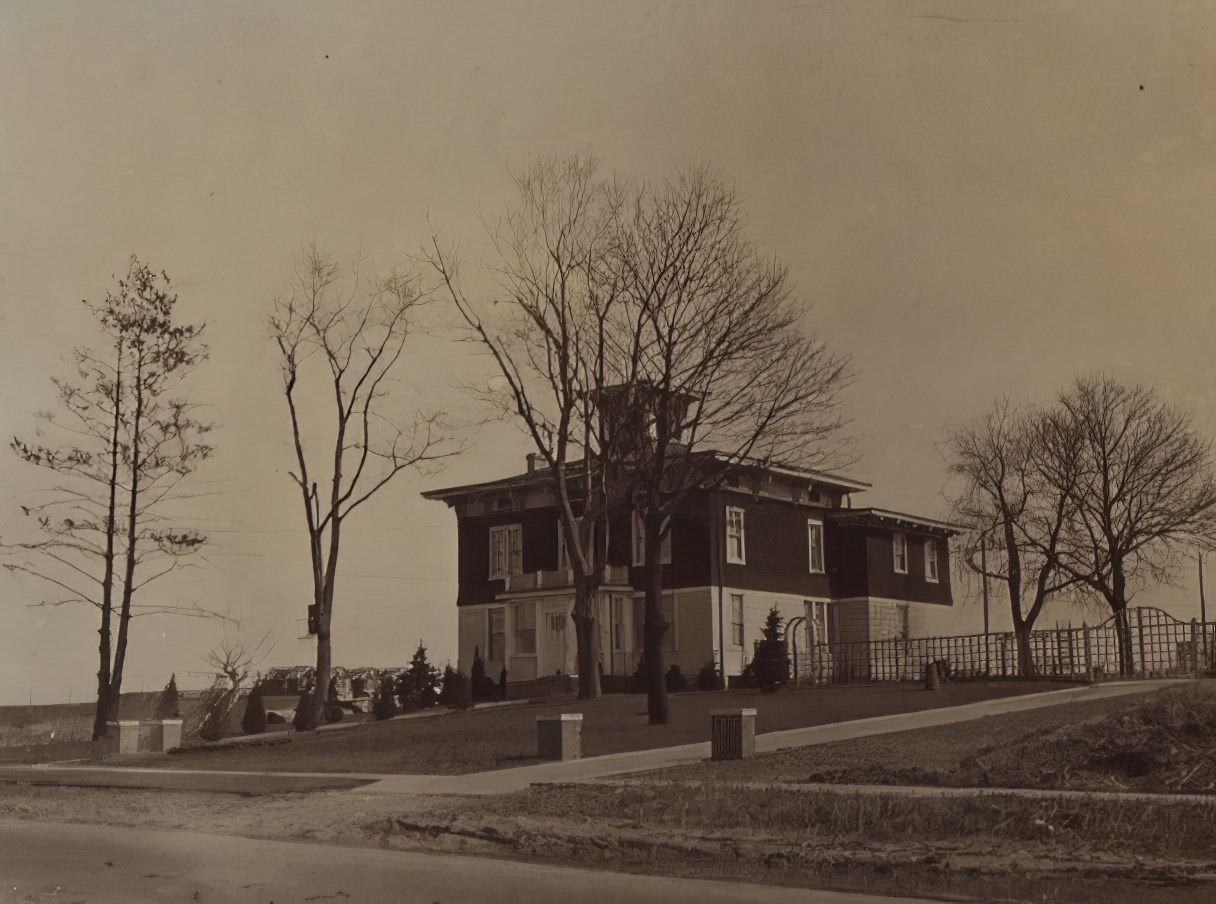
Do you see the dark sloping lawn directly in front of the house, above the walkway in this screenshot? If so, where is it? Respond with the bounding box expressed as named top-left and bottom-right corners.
top-left (107, 681), bottom-right (1075, 775)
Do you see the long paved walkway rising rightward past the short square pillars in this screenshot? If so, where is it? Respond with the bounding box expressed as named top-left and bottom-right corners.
top-left (0, 679), bottom-right (1189, 794)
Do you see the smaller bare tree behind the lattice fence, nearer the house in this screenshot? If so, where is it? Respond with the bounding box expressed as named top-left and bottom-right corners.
top-left (947, 399), bottom-right (1079, 676)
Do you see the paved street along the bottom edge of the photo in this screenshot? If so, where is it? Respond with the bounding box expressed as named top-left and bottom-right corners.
top-left (0, 822), bottom-right (927, 904)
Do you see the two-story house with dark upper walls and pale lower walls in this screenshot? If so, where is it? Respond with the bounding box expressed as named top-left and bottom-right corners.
top-left (423, 453), bottom-right (957, 683)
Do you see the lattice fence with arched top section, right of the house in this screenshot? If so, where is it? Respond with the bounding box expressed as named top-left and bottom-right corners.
top-left (790, 607), bottom-right (1216, 685)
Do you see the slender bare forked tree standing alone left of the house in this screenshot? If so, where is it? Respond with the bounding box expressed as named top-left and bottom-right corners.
top-left (270, 243), bottom-right (458, 728)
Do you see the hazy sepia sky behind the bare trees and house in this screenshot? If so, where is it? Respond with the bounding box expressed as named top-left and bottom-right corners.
top-left (0, 0), bottom-right (1216, 703)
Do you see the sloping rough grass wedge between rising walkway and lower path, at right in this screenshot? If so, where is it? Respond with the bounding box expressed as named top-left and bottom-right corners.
top-left (654, 680), bottom-right (1216, 794)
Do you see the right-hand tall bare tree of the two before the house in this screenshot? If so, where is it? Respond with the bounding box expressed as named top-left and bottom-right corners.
top-left (607, 167), bottom-right (849, 724)
